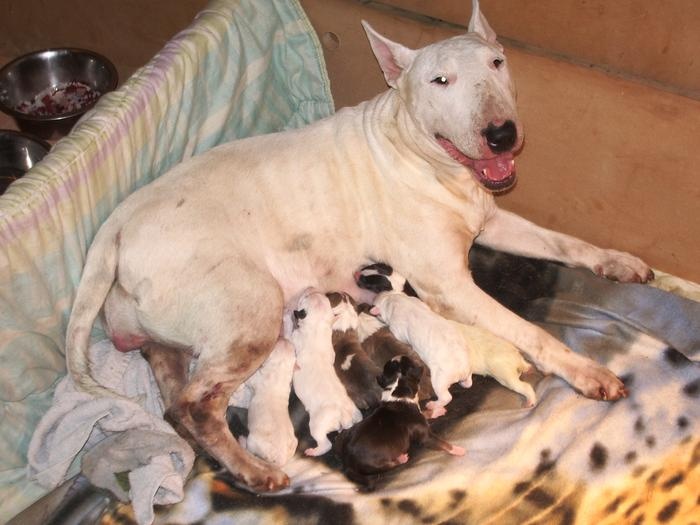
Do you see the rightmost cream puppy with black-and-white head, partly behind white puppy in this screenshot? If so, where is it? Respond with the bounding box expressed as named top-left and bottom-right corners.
top-left (355, 264), bottom-right (537, 410)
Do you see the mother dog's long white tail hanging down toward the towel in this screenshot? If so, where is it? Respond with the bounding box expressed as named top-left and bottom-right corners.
top-left (66, 221), bottom-right (126, 399)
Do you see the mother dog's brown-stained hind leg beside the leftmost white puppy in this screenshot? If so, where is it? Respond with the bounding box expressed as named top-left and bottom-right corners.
top-left (165, 264), bottom-right (289, 492)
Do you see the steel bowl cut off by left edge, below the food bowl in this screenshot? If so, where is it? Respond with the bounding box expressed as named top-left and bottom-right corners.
top-left (0, 129), bottom-right (51, 195)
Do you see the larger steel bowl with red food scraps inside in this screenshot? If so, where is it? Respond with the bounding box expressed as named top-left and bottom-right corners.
top-left (0, 48), bottom-right (118, 139)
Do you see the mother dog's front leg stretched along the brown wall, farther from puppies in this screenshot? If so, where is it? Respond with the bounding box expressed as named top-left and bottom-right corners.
top-left (476, 208), bottom-right (654, 283)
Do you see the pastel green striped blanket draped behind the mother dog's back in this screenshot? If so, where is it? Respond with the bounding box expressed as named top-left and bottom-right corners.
top-left (0, 0), bottom-right (334, 523)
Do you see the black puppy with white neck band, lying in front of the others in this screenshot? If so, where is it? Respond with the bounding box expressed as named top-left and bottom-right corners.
top-left (334, 356), bottom-right (464, 490)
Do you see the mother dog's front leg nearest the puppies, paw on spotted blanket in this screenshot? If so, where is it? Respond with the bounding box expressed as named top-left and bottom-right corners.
top-left (418, 271), bottom-right (627, 400)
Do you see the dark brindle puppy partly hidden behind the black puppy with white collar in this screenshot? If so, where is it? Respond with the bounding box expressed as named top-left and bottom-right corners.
top-left (357, 303), bottom-right (435, 402)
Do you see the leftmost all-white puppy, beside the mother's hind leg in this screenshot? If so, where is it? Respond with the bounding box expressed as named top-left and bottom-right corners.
top-left (229, 338), bottom-right (298, 467)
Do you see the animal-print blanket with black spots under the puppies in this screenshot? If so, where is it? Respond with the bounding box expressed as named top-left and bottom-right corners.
top-left (101, 247), bottom-right (700, 524)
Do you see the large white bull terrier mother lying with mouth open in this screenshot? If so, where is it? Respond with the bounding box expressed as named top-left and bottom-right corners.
top-left (66, 1), bottom-right (651, 491)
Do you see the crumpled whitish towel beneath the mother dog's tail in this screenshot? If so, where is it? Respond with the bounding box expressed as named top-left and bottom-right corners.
top-left (28, 341), bottom-right (194, 524)
